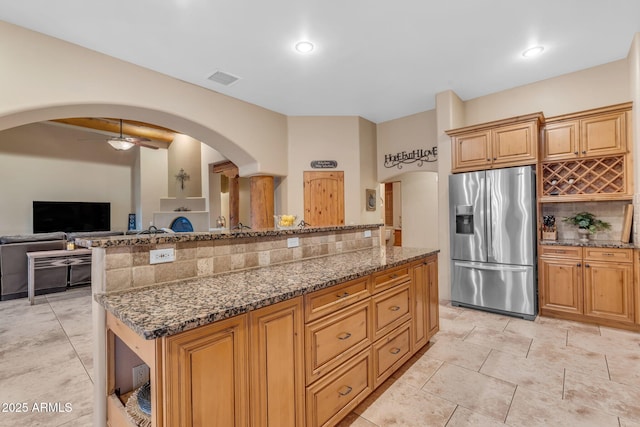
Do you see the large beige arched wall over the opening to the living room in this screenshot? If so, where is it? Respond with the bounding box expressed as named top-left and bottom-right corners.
top-left (0, 22), bottom-right (287, 176)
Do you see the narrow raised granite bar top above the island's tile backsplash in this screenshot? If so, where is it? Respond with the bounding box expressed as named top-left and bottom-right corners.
top-left (75, 224), bottom-right (383, 248)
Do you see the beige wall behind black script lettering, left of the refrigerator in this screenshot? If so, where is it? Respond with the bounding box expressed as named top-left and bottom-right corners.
top-left (377, 110), bottom-right (438, 182)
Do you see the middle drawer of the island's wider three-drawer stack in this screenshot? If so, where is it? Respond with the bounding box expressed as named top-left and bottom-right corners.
top-left (305, 299), bottom-right (373, 384)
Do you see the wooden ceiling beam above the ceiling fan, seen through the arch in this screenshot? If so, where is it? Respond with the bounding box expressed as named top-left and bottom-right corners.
top-left (51, 117), bottom-right (175, 144)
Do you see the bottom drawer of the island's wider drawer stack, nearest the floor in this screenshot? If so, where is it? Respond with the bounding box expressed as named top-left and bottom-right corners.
top-left (307, 349), bottom-right (373, 427)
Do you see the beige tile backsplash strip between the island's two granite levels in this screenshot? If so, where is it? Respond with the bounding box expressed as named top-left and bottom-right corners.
top-left (92, 229), bottom-right (381, 292)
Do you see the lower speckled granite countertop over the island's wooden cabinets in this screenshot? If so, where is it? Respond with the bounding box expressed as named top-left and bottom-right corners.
top-left (95, 247), bottom-right (439, 339)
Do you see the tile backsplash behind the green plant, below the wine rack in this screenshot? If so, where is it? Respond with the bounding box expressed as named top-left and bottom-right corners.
top-left (542, 200), bottom-right (633, 241)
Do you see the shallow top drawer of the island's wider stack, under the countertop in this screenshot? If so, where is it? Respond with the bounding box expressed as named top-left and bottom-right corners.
top-left (304, 277), bottom-right (369, 322)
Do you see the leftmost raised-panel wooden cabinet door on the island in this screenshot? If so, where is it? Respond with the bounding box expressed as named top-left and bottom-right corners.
top-left (165, 315), bottom-right (249, 427)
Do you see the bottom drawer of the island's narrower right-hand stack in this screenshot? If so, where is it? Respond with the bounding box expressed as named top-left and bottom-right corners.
top-left (373, 322), bottom-right (411, 387)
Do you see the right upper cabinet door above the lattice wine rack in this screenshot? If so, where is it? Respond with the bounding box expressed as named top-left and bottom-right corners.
top-left (580, 112), bottom-right (626, 156)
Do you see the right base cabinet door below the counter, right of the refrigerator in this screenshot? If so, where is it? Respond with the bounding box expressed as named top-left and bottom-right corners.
top-left (584, 261), bottom-right (634, 323)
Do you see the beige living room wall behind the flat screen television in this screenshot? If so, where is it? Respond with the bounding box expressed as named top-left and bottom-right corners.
top-left (0, 123), bottom-right (136, 235)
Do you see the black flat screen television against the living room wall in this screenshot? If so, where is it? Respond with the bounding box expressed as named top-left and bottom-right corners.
top-left (33, 201), bottom-right (111, 233)
